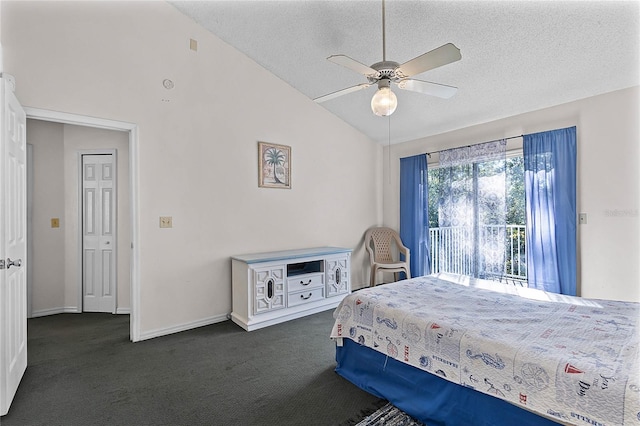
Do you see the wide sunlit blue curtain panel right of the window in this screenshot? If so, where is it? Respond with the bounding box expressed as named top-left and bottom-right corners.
top-left (523, 126), bottom-right (576, 296)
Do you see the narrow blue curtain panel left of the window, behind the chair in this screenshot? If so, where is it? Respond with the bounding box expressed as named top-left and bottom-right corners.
top-left (400, 154), bottom-right (431, 277)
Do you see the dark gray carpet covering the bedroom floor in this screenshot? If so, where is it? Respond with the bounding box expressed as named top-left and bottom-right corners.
top-left (0, 311), bottom-right (382, 426)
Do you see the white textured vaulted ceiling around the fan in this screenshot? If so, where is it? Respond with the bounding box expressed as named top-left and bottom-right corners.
top-left (170, 0), bottom-right (640, 144)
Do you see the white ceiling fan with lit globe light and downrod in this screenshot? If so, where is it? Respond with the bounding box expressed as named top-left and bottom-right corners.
top-left (314, 0), bottom-right (462, 116)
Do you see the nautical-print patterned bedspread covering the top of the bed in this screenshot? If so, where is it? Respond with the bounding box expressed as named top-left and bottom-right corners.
top-left (331, 276), bottom-right (640, 425)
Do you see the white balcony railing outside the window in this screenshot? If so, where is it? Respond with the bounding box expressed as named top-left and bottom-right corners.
top-left (429, 225), bottom-right (527, 285)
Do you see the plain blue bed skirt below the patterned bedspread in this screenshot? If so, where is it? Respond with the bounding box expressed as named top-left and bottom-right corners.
top-left (336, 339), bottom-right (557, 426)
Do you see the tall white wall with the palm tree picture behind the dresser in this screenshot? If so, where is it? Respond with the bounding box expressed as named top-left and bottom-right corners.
top-left (0, 1), bottom-right (382, 335)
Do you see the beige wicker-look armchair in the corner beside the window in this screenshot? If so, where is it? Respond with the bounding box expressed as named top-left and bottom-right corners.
top-left (364, 227), bottom-right (411, 287)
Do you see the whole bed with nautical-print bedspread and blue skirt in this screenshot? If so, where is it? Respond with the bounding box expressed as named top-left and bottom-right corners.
top-left (331, 274), bottom-right (640, 426)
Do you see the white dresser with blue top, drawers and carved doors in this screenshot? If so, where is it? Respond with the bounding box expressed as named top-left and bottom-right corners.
top-left (231, 247), bottom-right (351, 331)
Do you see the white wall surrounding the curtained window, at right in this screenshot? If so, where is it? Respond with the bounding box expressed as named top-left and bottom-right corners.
top-left (383, 87), bottom-right (640, 301)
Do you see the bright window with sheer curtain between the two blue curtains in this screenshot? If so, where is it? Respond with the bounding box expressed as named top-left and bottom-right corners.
top-left (428, 151), bottom-right (527, 283)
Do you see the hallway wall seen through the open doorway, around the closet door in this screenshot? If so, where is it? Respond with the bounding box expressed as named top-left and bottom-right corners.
top-left (27, 120), bottom-right (131, 316)
